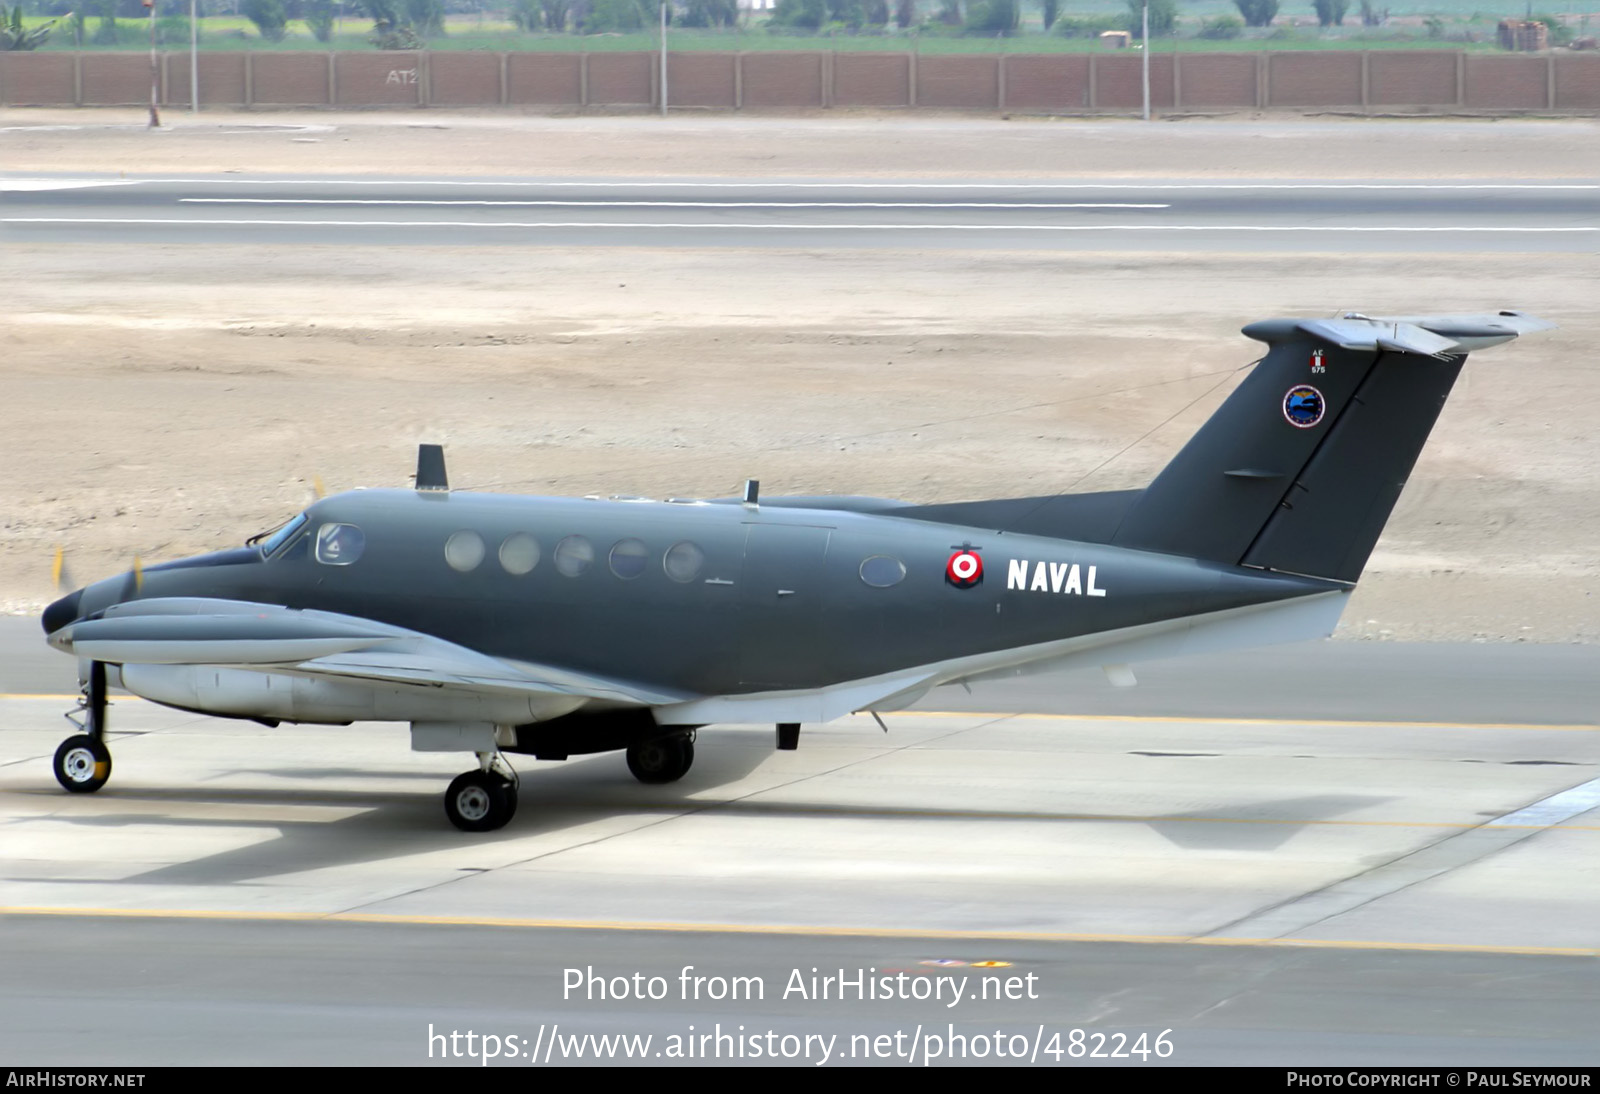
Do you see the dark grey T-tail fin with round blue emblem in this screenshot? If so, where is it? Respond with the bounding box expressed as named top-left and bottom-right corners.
top-left (1112, 312), bottom-right (1552, 582)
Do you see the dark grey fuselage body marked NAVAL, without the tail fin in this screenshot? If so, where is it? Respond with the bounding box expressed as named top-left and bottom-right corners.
top-left (56, 489), bottom-right (1341, 694)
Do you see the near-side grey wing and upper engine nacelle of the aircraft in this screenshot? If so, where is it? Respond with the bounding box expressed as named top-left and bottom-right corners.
top-left (50, 597), bottom-right (691, 705)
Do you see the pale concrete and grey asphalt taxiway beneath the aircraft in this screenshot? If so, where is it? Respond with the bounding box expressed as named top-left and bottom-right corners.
top-left (0, 636), bottom-right (1600, 1065)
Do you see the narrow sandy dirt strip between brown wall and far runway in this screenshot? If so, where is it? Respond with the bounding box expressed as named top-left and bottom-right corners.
top-left (9, 109), bottom-right (1600, 179)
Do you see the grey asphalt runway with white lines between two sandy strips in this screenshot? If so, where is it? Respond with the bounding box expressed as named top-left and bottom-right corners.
top-left (0, 176), bottom-right (1600, 253)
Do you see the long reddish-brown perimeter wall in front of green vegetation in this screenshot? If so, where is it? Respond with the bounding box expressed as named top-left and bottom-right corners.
top-left (0, 50), bottom-right (1600, 114)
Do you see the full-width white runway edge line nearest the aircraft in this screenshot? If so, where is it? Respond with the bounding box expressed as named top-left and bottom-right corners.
top-left (0, 216), bottom-right (1600, 234)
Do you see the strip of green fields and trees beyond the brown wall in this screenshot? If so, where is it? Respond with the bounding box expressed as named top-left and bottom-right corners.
top-left (9, 0), bottom-right (1600, 54)
